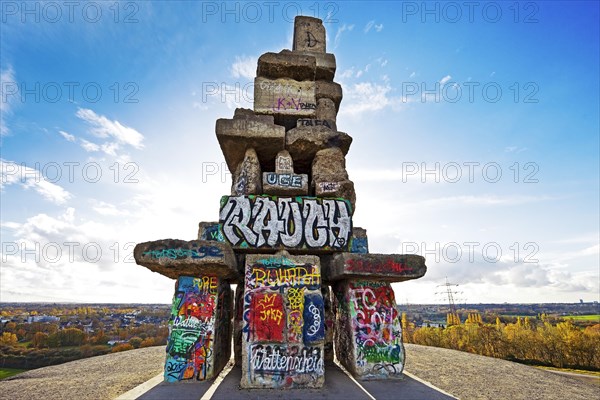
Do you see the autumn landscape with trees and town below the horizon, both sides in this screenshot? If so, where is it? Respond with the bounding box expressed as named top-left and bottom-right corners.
top-left (0, 302), bottom-right (600, 379)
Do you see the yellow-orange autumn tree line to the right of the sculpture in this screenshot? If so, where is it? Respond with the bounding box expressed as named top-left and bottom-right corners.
top-left (402, 313), bottom-right (600, 371)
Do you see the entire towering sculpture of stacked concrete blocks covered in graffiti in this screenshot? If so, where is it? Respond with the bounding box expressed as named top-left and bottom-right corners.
top-left (134, 17), bottom-right (426, 388)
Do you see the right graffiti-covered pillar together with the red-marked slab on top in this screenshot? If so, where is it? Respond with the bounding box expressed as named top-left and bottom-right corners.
top-left (327, 253), bottom-right (426, 380)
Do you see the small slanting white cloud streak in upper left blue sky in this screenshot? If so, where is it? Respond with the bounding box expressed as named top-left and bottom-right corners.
top-left (76, 108), bottom-right (144, 149)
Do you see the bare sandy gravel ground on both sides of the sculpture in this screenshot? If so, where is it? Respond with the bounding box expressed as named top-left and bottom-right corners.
top-left (0, 344), bottom-right (599, 400)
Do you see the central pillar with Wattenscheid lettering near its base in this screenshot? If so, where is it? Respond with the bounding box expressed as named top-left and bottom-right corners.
top-left (241, 251), bottom-right (325, 388)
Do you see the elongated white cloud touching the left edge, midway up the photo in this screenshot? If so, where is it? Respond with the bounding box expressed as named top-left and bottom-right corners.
top-left (0, 159), bottom-right (72, 204)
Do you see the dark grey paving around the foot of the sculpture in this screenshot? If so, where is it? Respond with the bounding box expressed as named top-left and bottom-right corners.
top-left (138, 364), bottom-right (453, 400)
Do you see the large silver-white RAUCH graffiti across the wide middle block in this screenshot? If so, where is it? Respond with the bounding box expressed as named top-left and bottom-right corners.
top-left (219, 196), bottom-right (352, 250)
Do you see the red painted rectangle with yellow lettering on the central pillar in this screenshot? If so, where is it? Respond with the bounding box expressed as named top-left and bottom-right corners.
top-left (250, 292), bottom-right (285, 342)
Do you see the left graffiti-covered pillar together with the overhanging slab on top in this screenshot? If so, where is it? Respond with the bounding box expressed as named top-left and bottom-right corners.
top-left (134, 239), bottom-right (238, 382)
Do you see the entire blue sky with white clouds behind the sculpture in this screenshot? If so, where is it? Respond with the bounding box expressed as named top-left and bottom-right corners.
top-left (0, 1), bottom-right (600, 303)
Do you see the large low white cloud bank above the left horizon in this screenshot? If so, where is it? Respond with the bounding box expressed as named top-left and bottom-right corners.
top-left (0, 208), bottom-right (172, 303)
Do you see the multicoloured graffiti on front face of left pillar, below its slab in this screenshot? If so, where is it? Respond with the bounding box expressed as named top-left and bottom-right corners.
top-left (165, 276), bottom-right (218, 382)
